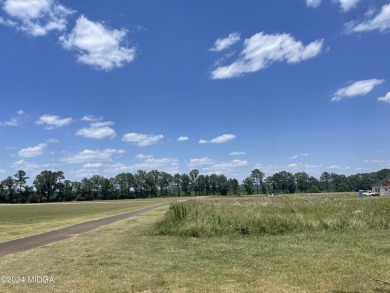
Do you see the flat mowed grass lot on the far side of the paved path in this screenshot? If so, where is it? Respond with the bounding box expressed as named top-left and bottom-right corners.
top-left (0, 198), bottom-right (172, 242)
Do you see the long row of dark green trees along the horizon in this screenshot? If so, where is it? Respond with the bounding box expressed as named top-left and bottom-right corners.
top-left (0, 169), bottom-right (390, 203)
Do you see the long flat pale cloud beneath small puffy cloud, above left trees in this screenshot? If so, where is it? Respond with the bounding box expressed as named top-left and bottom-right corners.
top-left (60, 149), bottom-right (125, 164)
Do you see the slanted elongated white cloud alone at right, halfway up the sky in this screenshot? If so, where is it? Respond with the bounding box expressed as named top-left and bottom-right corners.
top-left (331, 78), bottom-right (384, 101)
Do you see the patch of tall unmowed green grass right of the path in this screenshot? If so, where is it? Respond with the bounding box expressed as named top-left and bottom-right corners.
top-left (155, 195), bottom-right (390, 237)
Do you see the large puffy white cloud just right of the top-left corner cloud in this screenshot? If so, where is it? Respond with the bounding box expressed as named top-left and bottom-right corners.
top-left (60, 16), bottom-right (136, 70)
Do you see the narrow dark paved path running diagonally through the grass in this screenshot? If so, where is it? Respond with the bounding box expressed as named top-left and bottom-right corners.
top-left (0, 203), bottom-right (168, 257)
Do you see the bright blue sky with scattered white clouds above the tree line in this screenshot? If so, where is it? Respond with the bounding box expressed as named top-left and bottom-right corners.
top-left (0, 0), bottom-right (390, 180)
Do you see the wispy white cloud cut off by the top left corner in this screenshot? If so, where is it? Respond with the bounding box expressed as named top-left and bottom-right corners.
top-left (3, 0), bottom-right (74, 36)
